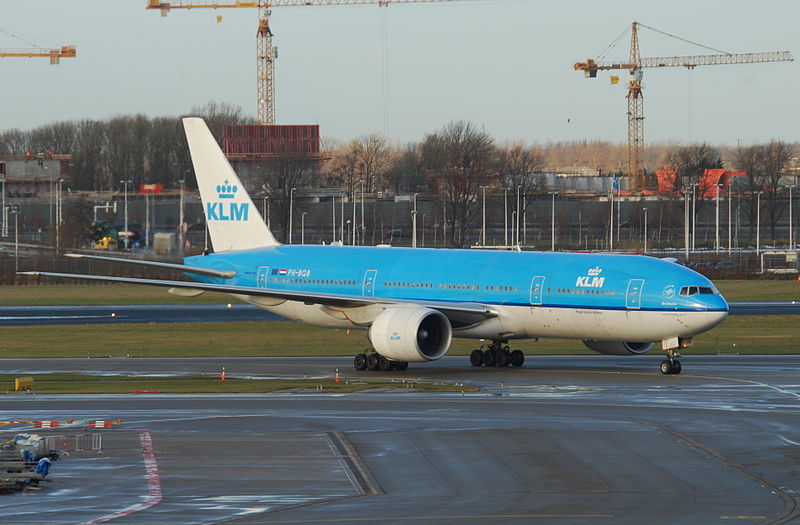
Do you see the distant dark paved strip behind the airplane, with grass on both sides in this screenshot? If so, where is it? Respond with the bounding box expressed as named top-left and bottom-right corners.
top-left (0, 301), bottom-right (800, 326)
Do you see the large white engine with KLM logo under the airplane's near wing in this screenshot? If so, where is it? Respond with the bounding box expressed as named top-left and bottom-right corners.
top-left (369, 307), bottom-right (453, 362)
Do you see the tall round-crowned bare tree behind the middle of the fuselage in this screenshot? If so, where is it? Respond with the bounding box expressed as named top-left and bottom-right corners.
top-left (421, 121), bottom-right (496, 246)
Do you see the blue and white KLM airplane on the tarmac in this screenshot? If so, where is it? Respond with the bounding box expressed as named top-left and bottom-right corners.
top-left (23, 118), bottom-right (728, 374)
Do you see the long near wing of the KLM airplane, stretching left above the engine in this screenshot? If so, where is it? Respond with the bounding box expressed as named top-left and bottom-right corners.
top-left (20, 272), bottom-right (498, 324)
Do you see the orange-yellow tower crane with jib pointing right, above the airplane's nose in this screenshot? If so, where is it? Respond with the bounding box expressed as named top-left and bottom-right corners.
top-left (573, 22), bottom-right (794, 191)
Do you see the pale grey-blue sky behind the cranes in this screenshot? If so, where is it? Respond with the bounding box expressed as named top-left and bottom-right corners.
top-left (0, 0), bottom-right (800, 145)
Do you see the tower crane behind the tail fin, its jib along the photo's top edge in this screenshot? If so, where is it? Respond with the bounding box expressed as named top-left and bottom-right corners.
top-left (147, 0), bottom-right (457, 125)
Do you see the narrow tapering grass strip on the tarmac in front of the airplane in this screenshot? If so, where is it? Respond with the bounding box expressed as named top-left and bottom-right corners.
top-left (0, 374), bottom-right (478, 395)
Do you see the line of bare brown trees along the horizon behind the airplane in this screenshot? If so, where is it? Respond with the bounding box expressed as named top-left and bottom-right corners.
top-left (0, 102), bottom-right (797, 246)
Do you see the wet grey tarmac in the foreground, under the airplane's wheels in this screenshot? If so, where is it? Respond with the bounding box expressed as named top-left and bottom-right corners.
top-left (0, 355), bottom-right (800, 524)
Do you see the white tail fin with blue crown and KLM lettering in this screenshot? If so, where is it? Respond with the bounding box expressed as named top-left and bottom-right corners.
top-left (183, 117), bottom-right (280, 252)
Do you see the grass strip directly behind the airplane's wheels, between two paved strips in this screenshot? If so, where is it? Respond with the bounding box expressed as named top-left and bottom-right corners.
top-left (0, 315), bottom-right (800, 358)
